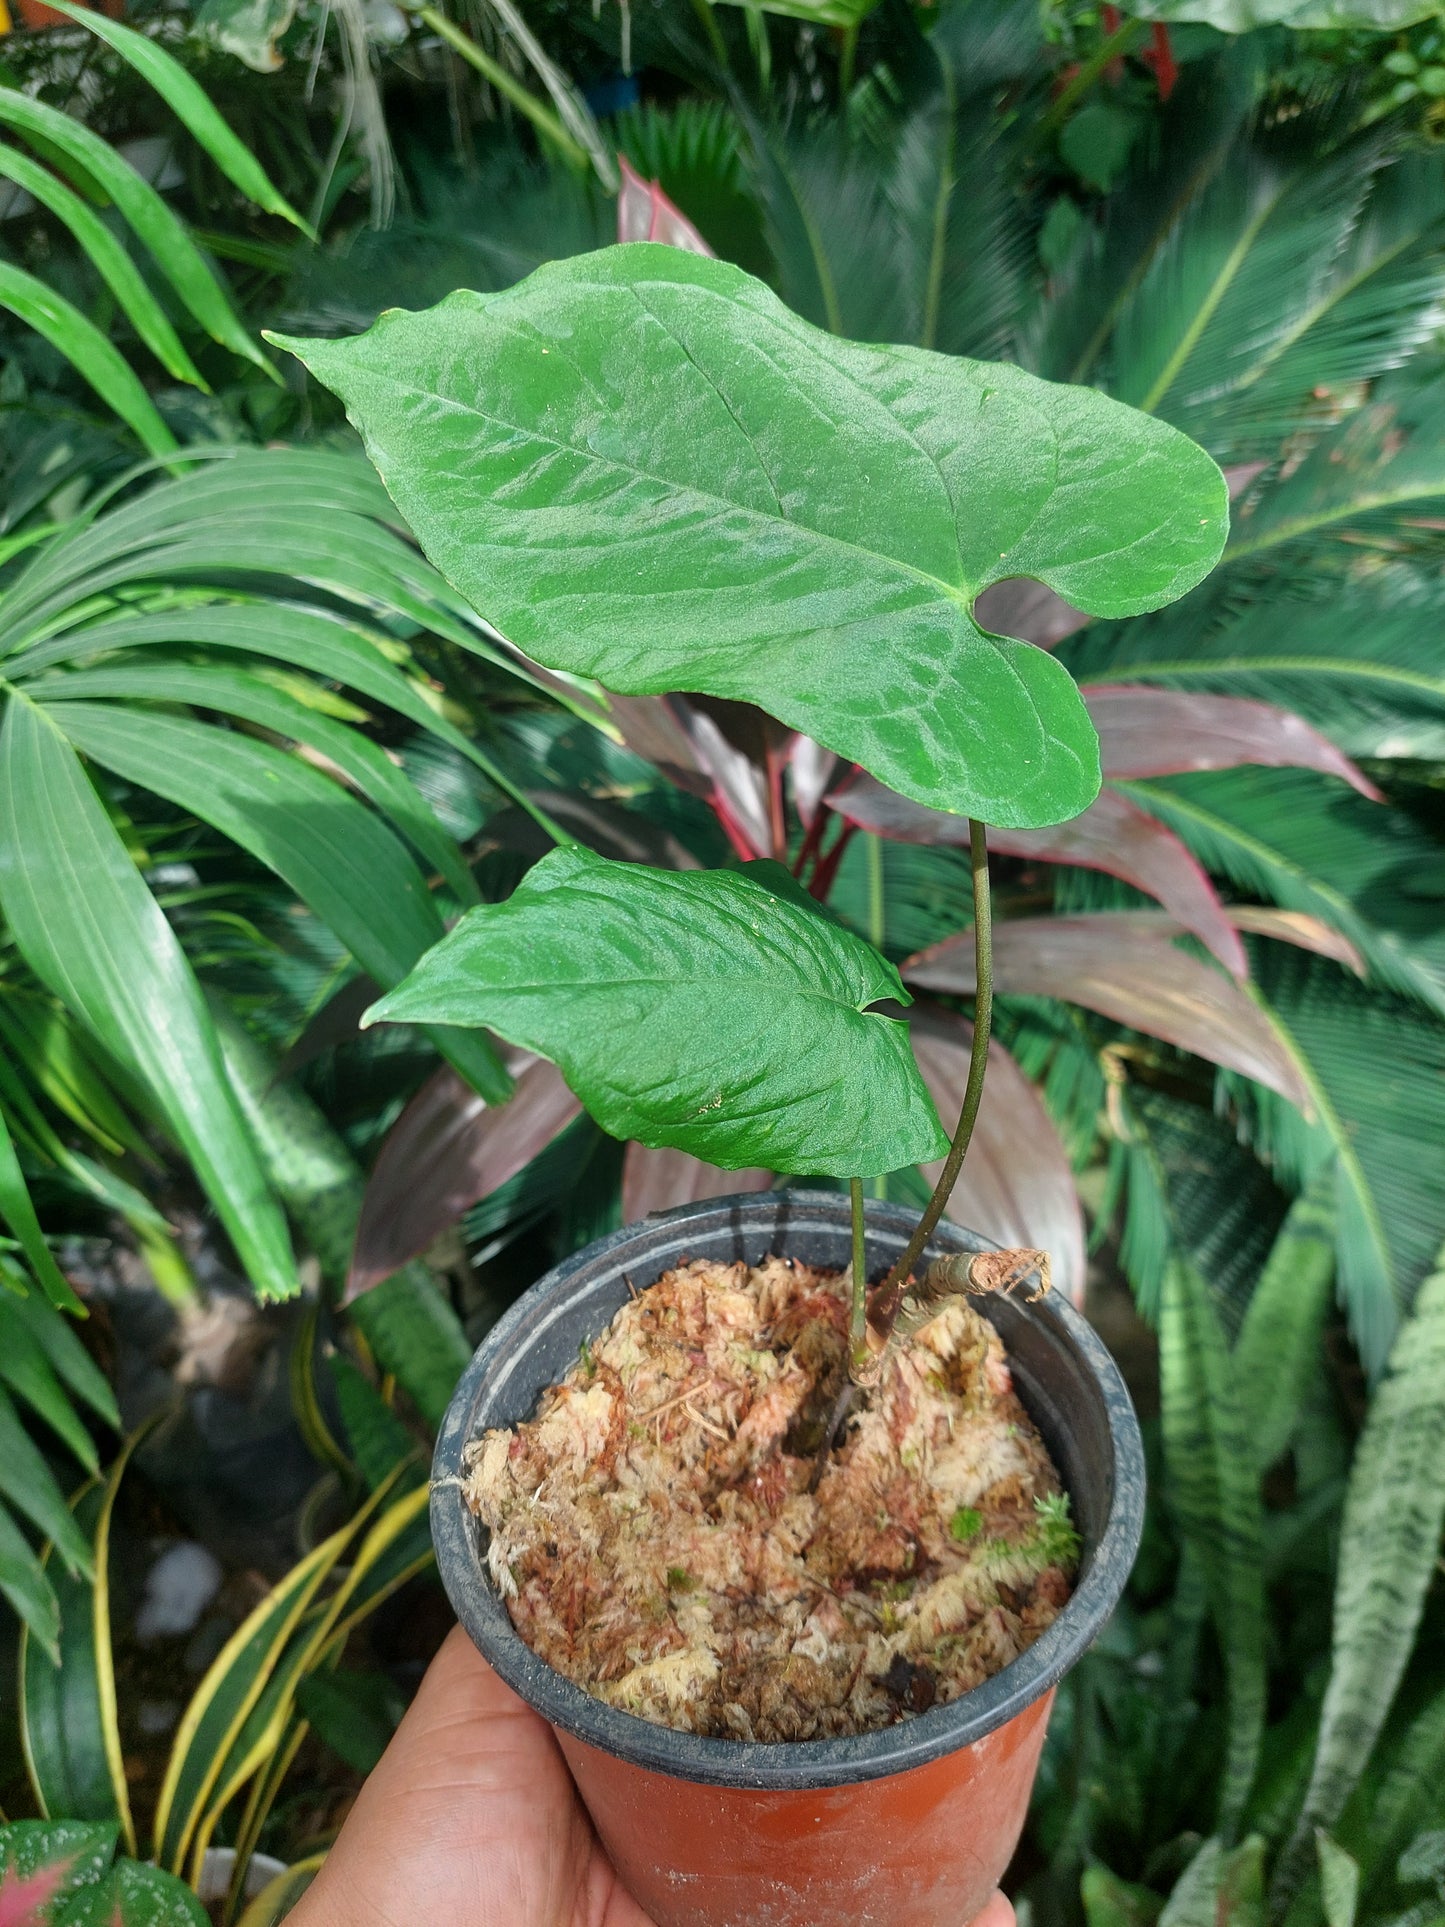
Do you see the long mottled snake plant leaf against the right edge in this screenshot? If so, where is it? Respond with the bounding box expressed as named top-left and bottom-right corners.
top-left (1279, 1254), bottom-right (1445, 1892)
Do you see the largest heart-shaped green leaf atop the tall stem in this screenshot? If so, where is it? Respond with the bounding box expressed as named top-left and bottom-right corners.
top-left (274, 243), bottom-right (1227, 825)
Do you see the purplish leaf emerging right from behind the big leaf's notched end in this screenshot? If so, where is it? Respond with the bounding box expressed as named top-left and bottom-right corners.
top-left (1083, 684), bottom-right (1381, 804)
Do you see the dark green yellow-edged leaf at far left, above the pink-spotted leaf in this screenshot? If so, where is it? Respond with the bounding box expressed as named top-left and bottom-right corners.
top-left (19, 1436), bottom-right (137, 1854)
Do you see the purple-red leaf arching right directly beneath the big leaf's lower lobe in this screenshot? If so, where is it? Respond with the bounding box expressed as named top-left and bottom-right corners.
top-left (828, 777), bottom-right (1248, 977)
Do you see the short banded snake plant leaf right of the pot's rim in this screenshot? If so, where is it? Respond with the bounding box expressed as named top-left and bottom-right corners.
top-left (1233, 1174), bottom-right (1335, 1472)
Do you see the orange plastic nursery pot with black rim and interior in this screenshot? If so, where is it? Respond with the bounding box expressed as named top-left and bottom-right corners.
top-left (432, 1191), bottom-right (1144, 1927)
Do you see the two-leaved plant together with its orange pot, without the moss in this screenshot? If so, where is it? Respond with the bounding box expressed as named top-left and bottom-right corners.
top-left (269, 245), bottom-right (1227, 1927)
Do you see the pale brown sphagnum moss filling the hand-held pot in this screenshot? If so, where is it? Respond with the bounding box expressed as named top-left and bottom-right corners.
top-left (466, 1258), bottom-right (1077, 1740)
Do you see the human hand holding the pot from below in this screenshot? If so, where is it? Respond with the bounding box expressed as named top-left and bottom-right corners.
top-left (289, 1626), bottom-right (1013, 1927)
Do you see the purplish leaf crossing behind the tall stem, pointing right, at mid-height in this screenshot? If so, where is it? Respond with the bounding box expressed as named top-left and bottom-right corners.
top-left (904, 910), bottom-right (1310, 1116)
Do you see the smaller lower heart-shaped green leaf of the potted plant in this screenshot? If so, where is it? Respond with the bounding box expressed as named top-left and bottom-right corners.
top-left (368, 848), bottom-right (948, 1177)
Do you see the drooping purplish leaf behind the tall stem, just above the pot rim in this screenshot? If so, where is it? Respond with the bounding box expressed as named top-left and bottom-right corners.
top-left (909, 1010), bottom-right (1085, 1305)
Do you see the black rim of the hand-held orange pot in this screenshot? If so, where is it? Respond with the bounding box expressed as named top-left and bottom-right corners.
top-left (432, 1187), bottom-right (1144, 1788)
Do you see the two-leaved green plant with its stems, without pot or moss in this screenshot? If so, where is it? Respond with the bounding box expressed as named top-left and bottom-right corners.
top-left (276, 243), bottom-right (1227, 1372)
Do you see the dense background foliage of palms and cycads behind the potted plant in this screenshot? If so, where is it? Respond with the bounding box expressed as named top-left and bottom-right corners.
top-left (0, 0), bottom-right (1445, 1927)
